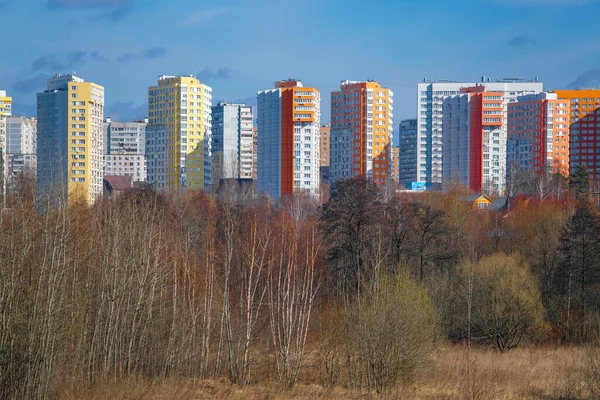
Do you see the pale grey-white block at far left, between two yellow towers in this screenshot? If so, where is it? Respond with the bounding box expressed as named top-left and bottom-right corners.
top-left (6, 117), bottom-right (37, 182)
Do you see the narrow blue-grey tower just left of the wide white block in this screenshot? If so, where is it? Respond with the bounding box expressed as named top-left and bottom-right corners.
top-left (398, 118), bottom-right (418, 186)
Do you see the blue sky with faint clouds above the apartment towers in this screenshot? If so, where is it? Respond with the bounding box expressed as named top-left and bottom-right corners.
top-left (0, 0), bottom-right (600, 130)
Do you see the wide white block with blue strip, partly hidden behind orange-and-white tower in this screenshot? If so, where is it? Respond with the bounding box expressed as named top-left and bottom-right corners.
top-left (415, 77), bottom-right (543, 184)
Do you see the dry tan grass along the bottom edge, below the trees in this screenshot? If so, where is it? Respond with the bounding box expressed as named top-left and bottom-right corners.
top-left (60, 346), bottom-right (589, 400)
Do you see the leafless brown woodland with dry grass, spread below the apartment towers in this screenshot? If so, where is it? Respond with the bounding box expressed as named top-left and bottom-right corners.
top-left (0, 173), bottom-right (600, 400)
